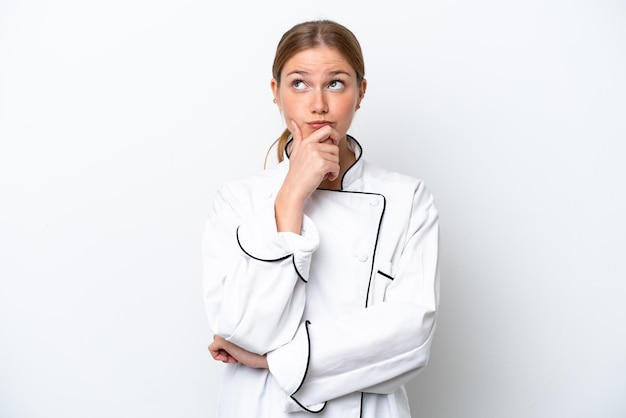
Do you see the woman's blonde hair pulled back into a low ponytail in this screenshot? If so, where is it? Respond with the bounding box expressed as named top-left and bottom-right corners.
top-left (265, 20), bottom-right (365, 162)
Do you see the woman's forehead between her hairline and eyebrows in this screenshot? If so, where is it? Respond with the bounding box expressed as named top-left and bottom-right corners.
top-left (283, 45), bottom-right (356, 75)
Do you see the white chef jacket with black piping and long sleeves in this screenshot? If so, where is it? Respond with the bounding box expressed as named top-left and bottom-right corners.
top-left (203, 137), bottom-right (439, 418)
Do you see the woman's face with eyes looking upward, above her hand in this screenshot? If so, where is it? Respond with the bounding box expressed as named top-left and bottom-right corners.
top-left (272, 46), bottom-right (366, 138)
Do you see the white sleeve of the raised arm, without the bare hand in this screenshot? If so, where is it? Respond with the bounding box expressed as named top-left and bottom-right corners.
top-left (202, 184), bottom-right (318, 354)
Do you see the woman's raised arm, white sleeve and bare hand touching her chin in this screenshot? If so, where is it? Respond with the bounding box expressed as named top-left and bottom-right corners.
top-left (203, 122), bottom-right (339, 354)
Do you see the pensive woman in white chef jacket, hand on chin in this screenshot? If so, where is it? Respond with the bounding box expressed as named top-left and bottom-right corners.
top-left (203, 21), bottom-right (439, 418)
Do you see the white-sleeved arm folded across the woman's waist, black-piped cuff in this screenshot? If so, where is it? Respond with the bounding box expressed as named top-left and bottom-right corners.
top-left (267, 185), bottom-right (439, 409)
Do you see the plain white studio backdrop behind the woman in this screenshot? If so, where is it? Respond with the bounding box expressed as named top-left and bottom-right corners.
top-left (0, 0), bottom-right (626, 418)
